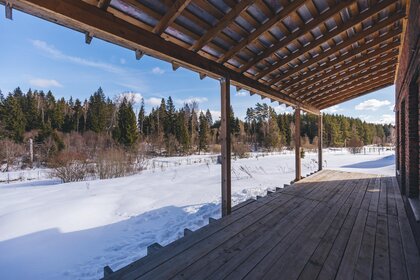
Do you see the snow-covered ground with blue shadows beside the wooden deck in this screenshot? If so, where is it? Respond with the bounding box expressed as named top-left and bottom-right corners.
top-left (0, 150), bottom-right (395, 279)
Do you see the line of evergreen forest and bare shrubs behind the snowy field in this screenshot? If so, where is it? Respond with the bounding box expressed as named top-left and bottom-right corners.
top-left (0, 88), bottom-right (394, 165)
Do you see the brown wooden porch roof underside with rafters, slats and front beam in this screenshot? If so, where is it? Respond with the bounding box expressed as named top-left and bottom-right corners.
top-left (0, 0), bottom-right (406, 114)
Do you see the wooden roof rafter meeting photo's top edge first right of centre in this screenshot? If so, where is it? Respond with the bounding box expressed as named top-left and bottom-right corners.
top-left (190, 0), bottom-right (255, 51)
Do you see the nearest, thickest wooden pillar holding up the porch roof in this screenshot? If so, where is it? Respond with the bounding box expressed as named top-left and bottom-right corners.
top-left (220, 78), bottom-right (232, 217)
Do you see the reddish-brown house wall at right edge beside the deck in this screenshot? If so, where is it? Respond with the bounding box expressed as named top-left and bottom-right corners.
top-left (395, 0), bottom-right (420, 249)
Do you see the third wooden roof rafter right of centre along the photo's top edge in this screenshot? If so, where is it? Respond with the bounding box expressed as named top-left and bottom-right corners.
top-left (240, 0), bottom-right (356, 72)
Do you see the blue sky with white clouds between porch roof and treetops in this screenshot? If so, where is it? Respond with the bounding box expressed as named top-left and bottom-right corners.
top-left (0, 11), bottom-right (394, 123)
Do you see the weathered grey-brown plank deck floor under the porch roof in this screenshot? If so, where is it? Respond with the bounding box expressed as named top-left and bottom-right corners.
top-left (107, 170), bottom-right (420, 279)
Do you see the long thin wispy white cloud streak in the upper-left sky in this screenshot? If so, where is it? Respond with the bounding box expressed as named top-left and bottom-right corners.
top-left (32, 40), bottom-right (123, 73)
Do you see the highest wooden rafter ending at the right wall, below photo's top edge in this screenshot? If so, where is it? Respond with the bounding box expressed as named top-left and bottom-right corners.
top-left (269, 13), bottom-right (404, 85)
